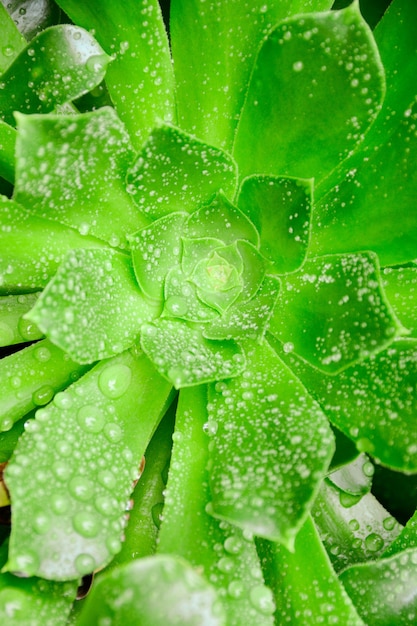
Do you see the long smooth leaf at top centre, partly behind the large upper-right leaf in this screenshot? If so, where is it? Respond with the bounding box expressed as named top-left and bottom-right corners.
top-left (170, 0), bottom-right (332, 150)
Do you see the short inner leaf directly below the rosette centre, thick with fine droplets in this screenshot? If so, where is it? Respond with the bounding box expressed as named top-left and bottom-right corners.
top-left (141, 319), bottom-right (245, 389)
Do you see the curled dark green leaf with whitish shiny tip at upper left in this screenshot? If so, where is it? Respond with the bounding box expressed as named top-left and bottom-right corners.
top-left (0, 24), bottom-right (110, 124)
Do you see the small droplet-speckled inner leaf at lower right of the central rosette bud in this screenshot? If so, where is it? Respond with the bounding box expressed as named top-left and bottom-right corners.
top-left (203, 276), bottom-right (279, 340)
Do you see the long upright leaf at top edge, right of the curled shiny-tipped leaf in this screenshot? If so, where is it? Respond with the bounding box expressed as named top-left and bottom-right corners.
top-left (54, 0), bottom-right (175, 148)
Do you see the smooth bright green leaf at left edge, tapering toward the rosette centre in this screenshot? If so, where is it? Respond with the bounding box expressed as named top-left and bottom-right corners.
top-left (0, 196), bottom-right (106, 293)
